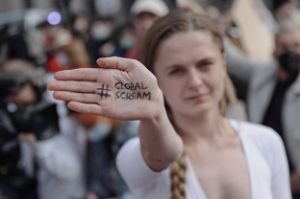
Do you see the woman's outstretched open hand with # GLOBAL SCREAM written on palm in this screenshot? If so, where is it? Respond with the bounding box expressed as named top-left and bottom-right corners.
top-left (48, 57), bottom-right (163, 119)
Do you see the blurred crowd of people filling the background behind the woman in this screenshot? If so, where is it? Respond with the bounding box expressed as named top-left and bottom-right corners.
top-left (0, 0), bottom-right (300, 199)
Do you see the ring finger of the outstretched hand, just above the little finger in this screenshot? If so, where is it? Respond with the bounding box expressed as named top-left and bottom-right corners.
top-left (53, 91), bottom-right (98, 103)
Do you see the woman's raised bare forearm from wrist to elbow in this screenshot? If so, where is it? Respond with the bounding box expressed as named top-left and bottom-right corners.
top-left (139, 109), bottom-right (183, 171)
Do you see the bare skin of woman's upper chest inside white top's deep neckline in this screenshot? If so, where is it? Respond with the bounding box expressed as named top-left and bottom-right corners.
top-left (186, 123), bottom-right (251, 199)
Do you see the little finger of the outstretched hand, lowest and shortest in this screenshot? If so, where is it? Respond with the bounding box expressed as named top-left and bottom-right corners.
top-left (67, 101), bottom-right (102, 115)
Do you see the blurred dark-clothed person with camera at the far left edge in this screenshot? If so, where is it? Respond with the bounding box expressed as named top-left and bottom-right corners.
top-left (0, 71), bottom-right (39, 199)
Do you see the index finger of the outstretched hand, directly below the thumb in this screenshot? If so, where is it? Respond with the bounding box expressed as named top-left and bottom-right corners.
top-left (54, 68), bottom-right (99, 81)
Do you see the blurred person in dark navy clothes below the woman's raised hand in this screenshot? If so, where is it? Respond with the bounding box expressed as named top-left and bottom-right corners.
top-left (84, 113), bottom-right (138, 199)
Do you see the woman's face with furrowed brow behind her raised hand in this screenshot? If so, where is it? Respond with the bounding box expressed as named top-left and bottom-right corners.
top-left (154, 31), bottom-right (226, 117)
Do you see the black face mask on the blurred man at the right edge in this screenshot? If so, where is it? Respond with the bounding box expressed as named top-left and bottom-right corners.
top-left (278, 50), bottom-right (300, 79)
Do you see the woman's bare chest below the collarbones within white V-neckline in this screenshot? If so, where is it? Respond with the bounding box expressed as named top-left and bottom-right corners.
top-left (189, 144), bottom-right (251, 199)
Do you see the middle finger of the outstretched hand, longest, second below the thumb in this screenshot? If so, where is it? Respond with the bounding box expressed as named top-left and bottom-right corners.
top-left (48, 80), bottom-right (97, 93)
